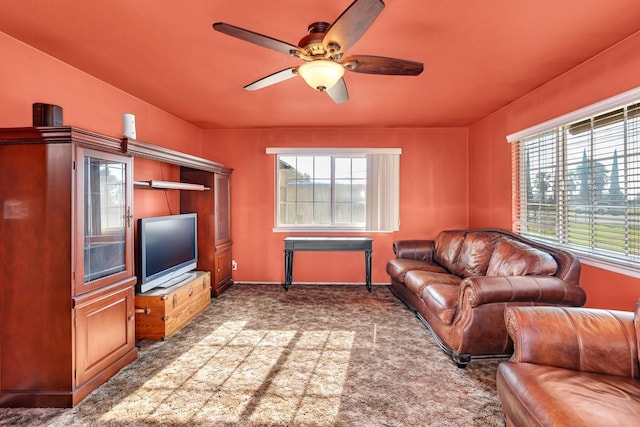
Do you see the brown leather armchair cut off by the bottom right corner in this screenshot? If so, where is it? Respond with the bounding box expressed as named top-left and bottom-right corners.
top-left (496, 306), bottom-right (640, 427)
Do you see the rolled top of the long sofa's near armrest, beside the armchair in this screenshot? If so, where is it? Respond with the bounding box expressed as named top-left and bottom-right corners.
top-left (460, 275), bottom-right (587, 307)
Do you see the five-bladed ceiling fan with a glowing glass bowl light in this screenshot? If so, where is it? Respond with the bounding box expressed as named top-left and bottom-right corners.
top-left (213, 0), bottom-right (423, 104)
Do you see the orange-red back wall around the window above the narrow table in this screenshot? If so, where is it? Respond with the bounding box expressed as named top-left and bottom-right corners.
top-left (204, 129), bottom-right (468, 283)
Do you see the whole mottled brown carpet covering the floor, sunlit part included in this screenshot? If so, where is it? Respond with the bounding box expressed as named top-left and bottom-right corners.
top-left (0, 284), bottom-right (504, 427)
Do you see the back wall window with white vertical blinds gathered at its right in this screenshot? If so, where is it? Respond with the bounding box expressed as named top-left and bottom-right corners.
top-left (267, 148), bottom-right (400, 231)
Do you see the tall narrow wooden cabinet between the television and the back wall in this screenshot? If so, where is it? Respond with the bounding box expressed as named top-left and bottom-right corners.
top-left (180, 167), bottom-right (233, 297)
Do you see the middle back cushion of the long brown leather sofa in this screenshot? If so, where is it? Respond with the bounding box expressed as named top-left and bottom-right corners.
top-left (454, 231), bottom-right (500, 277)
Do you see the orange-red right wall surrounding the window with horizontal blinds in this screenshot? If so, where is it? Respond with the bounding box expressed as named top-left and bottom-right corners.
top-left (469, 33), bottom-right (640, 310)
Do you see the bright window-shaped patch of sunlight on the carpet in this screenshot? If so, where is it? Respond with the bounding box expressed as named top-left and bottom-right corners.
top-left (100, 321), bottom-right (355, 426)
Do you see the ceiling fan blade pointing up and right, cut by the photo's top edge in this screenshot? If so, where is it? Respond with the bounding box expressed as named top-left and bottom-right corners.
top-left (322, 0), bottom-right (384, 54)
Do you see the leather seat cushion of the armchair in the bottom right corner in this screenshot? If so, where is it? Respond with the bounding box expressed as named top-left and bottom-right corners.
top-left (497, 362), bottom-right (640, 426)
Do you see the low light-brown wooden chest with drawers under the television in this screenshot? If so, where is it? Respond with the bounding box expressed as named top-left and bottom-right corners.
top-left (135, 271), bottom-right (211, 340)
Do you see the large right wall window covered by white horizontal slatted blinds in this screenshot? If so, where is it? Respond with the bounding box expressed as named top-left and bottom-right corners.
top-left (508, 90), bottom-right (640, 275)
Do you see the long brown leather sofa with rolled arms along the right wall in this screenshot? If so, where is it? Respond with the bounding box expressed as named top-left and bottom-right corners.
top-left (387, 229), bottom-right (586, 368)
